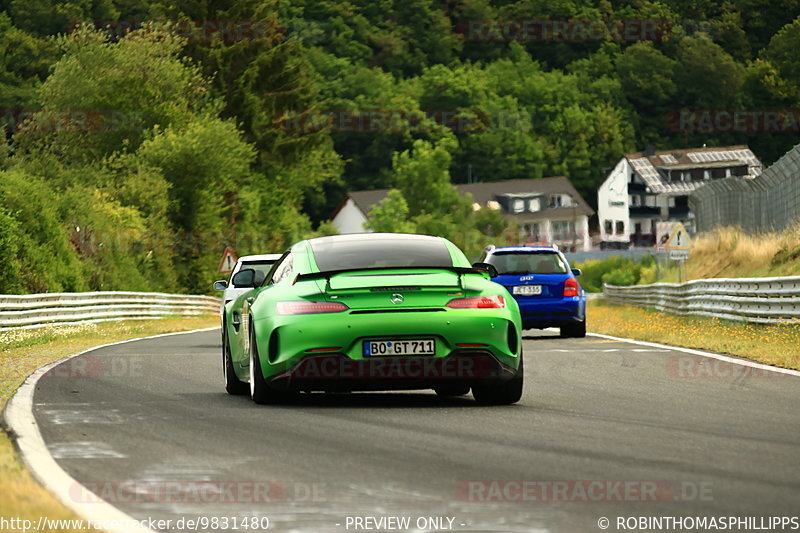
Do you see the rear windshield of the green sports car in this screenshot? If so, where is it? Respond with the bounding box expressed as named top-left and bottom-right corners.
top-left (310, 238), bottom-right (453, 272)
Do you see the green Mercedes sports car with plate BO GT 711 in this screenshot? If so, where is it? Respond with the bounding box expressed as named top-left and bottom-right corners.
top-left (222, 233), bottom-right (523, 404)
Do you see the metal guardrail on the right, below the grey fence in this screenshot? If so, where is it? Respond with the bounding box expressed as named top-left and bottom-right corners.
top-left (603, 276), bottom-right (800, 324)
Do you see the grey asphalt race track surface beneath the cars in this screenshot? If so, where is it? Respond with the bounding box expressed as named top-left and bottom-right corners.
top-left (34, 331), bottom-right (800, 533)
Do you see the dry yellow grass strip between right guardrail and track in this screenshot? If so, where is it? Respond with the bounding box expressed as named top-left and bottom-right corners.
top-left (587, 300), bottom-right (800, 370)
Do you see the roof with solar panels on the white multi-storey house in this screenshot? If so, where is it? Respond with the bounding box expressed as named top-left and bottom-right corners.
top-left (624, 144), bottom-right (762, 194)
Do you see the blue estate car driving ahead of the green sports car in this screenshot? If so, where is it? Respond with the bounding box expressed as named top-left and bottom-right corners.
top-left (480, 246), bottom-right (586, 337)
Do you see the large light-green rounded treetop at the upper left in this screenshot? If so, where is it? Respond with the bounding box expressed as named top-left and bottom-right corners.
top-left (16, 25), bottom-right (218, 164)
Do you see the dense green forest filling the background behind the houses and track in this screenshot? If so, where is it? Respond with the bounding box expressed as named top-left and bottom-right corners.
top-left (0, 0), bottom-right (800, 293)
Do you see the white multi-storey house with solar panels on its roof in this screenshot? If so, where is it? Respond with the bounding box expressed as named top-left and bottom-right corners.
top-left (597, 145), bottom-right (762, 248)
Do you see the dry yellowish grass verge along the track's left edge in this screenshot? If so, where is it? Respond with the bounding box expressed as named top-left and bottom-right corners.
top-left (0, 317), bottom-right (219, 532)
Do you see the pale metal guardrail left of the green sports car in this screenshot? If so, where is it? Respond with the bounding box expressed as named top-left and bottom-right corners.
top-left (0, 292), bottom-right (220, 331)
